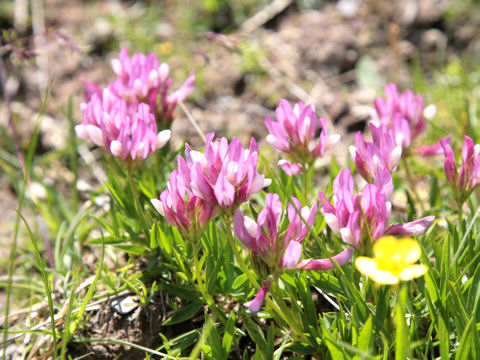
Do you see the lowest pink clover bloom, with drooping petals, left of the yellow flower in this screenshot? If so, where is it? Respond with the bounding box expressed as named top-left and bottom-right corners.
top-left (233, 193), bottom-right (351, 311)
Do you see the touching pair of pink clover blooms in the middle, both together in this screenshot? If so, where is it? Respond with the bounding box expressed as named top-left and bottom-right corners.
top-left (151, 133), bottom-right (271, 232)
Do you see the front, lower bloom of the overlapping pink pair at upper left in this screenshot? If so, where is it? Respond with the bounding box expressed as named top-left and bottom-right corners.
top-left (75, 88), bottom-right (170, 160)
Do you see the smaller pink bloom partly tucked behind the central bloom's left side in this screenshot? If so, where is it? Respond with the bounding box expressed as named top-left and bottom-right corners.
top-left (150, 165), bottom-right (216, 241)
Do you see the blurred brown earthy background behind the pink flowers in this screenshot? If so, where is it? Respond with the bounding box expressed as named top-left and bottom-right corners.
top-left (0, 0), bottom-right (480, 151)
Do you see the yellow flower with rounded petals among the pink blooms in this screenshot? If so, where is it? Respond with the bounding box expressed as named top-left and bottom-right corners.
top-left (355, 236), bottom-right (427, 285)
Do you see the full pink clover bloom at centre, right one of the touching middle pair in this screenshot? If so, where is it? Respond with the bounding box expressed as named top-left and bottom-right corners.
top-left (179, 133), bottom-right (272, 216)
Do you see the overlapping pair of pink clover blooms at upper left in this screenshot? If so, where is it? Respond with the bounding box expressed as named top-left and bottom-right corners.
top-left (75, 49), bottom-right (195, 160)
